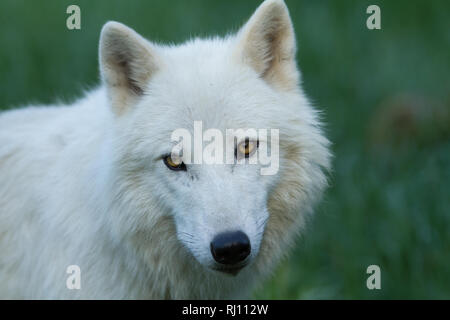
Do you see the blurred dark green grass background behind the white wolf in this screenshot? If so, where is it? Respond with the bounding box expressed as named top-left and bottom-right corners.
top-left (0, 0), bottom-right (450, 299)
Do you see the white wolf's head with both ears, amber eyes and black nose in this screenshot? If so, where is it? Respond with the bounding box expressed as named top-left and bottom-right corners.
top-left (100, 0), bottom-right (329, 280)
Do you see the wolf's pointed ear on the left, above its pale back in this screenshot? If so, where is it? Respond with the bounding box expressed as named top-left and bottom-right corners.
top-left (99, 22), bottom-right (158, 113)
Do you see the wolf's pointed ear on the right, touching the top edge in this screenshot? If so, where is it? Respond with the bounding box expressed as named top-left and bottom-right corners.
top-left (237, 0), bottom-right (299, 90)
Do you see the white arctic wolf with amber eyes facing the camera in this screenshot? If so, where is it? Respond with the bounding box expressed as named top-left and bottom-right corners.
top-left (0, 0), bottom-right (330, 299)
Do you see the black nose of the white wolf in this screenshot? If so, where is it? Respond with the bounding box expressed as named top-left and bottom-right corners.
top-left (211, 231), bottom-right (251, 265)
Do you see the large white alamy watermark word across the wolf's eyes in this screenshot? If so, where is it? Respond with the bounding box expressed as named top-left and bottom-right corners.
top-left (171, 121), bottom-right (279, 175)
